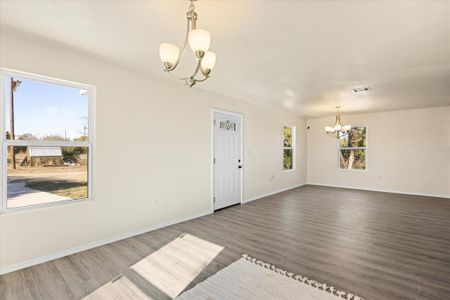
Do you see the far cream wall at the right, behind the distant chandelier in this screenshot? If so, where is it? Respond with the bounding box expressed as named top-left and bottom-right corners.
top-left (307, 106), bottom-right (450, 197)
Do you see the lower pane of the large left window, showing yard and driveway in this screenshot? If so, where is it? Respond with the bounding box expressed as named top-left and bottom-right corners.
top-left (7, 146), bottom-right (89, 208)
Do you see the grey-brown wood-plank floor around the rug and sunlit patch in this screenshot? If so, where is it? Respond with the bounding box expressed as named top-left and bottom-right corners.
top-left (0, 186), bottom-right (450, 300)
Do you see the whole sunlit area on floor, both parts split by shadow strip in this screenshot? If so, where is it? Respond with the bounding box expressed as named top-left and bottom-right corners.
top-left (83, 234), bottom-right (224, 300)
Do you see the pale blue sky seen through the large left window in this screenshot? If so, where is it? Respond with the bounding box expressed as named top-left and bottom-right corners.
top-left (5, 76), bottom-right (89, 140)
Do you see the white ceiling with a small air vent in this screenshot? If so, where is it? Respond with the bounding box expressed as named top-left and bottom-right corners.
top-left (0, 0), bottom-right (450, 117)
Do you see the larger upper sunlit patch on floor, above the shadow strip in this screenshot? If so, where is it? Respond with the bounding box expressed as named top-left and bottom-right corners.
top-left (131, 234), bottom-right (224, 299)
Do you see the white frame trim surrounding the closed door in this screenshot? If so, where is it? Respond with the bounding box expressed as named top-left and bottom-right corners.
top-left (210, 108), bottom-right (245, 213)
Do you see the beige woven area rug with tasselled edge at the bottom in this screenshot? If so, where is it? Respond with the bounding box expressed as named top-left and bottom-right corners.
top-left (176, 255), bottom-right (362, 300)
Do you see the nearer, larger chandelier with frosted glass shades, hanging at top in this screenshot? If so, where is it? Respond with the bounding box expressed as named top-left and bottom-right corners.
top-left (159, 0), bottom-right (216, 87)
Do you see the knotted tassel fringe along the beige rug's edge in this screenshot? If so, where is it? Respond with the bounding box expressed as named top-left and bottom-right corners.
top-left (242, 254), bottom-right (364, 300)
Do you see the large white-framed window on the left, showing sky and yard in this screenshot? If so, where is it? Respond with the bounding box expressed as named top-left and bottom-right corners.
top-left (1, 71), bottom-right (94, 210)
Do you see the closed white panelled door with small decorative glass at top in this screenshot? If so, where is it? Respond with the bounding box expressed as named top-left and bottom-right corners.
top-left (213, 112), bottom-right (242, 210)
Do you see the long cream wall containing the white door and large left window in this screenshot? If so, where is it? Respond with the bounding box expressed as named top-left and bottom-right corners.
top-left (0, 31), bottom-right (306, 269)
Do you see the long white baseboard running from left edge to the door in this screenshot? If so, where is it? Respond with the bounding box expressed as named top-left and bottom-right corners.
top-left (0, 210), bottom-right (213, 275)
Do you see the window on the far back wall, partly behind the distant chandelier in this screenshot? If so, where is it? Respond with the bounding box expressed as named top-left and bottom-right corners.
top-left (338, 126), bottom-right (367, 170)
